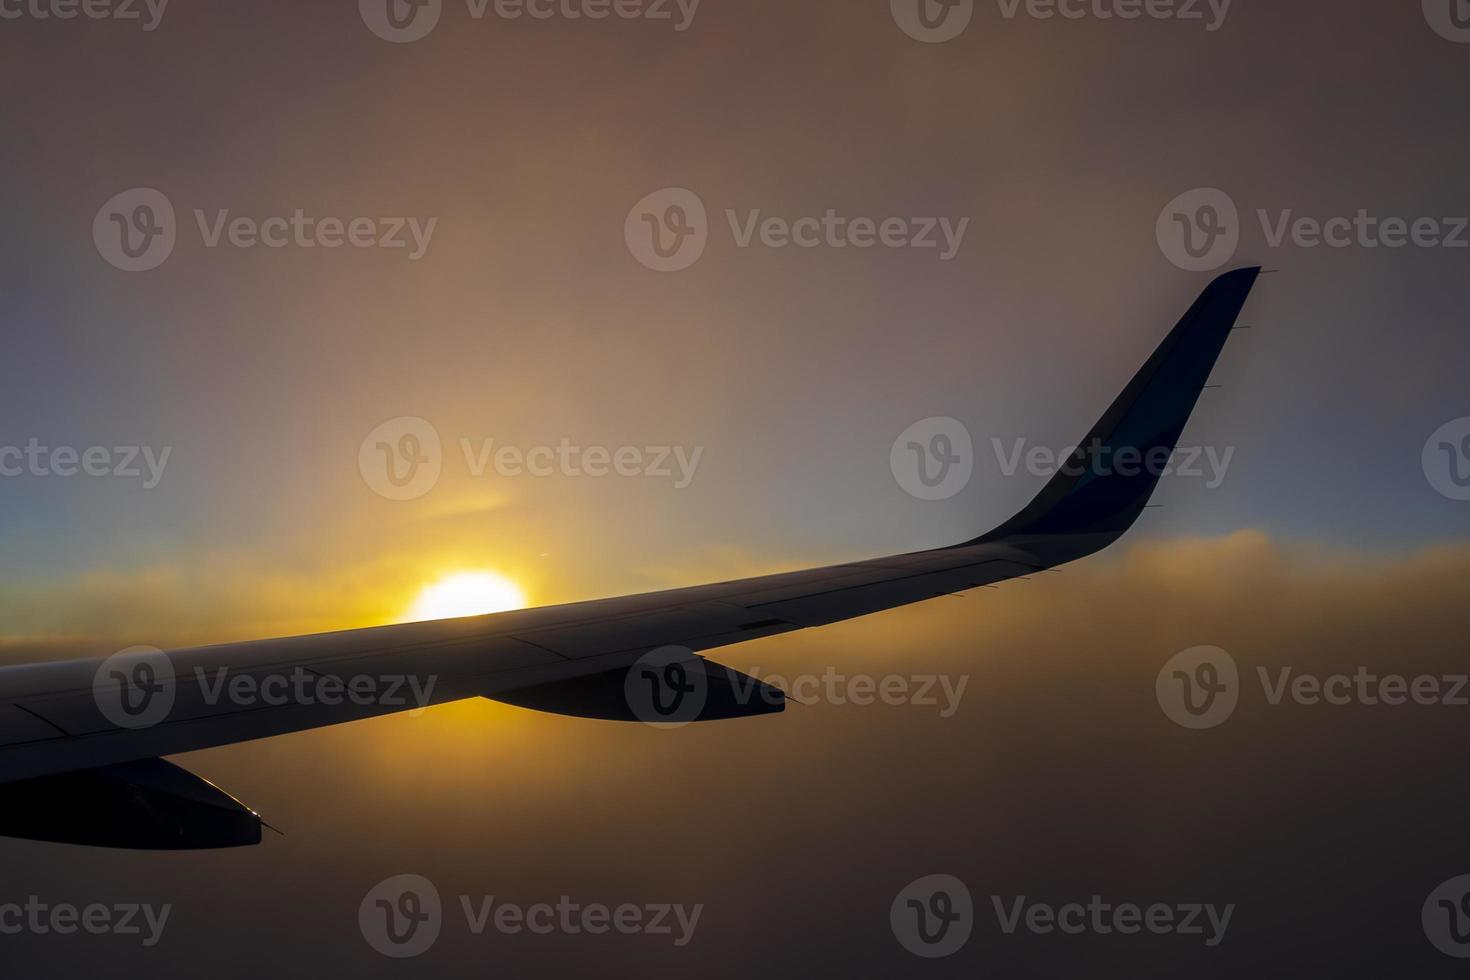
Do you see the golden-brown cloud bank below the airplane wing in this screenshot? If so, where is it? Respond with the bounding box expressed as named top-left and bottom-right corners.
top-left (9, 532), bottom-right (1470, 977)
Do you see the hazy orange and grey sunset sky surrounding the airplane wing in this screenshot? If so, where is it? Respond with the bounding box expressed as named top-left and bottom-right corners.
top-left (0, 0), bottom-right (1470, 976)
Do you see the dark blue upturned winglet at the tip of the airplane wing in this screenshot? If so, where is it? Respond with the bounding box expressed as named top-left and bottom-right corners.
top-left (956, 267), bottom-right (1261, 560)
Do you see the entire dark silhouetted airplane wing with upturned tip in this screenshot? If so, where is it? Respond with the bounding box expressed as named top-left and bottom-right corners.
top-left (0, 267), bottom-right (1260, 849)
